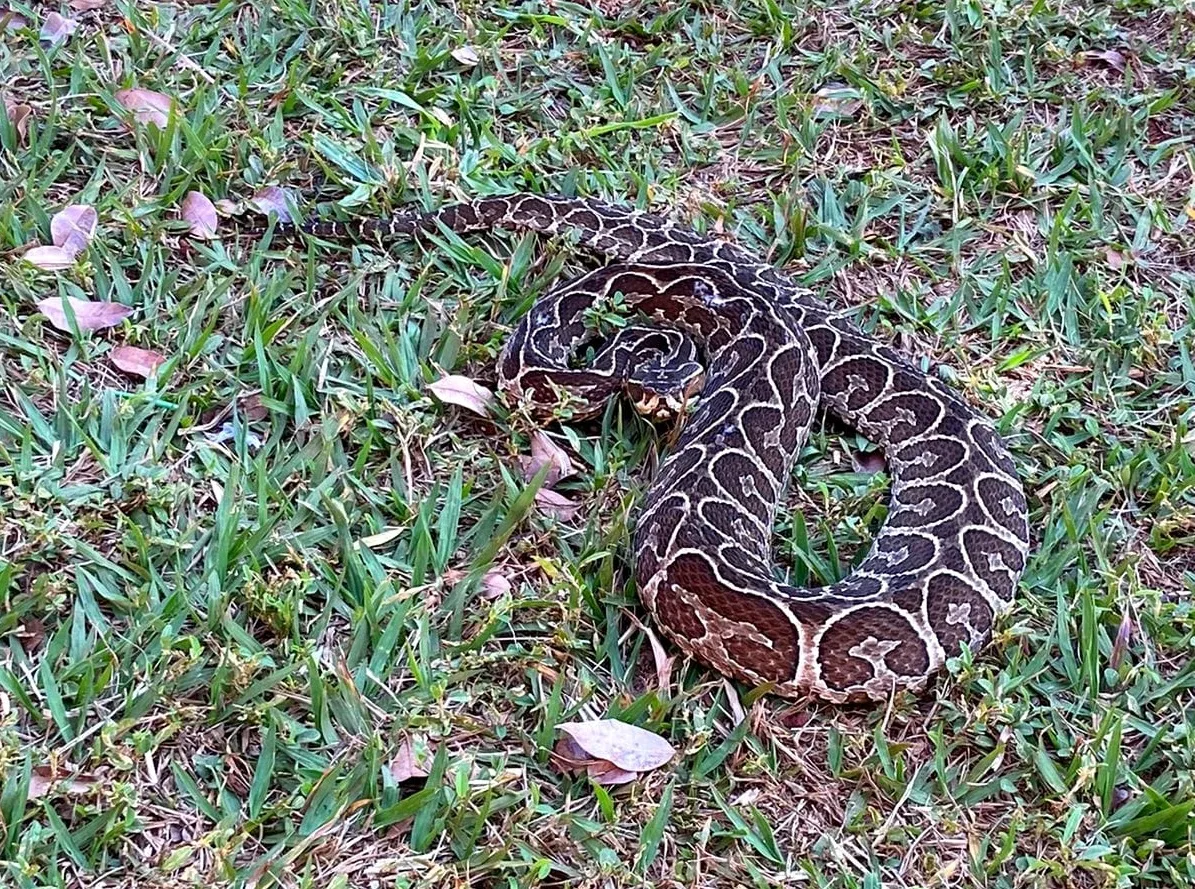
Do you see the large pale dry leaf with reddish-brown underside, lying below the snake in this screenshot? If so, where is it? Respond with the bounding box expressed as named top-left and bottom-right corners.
top-left (552, 719), bottom-right (676, 784)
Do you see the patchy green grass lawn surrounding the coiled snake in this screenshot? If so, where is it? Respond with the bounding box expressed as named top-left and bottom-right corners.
top-left (0, 0), bottom-right (1195, 889)
